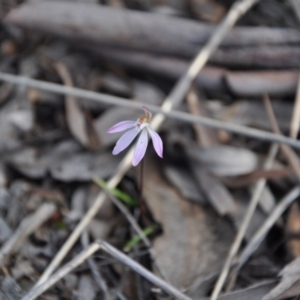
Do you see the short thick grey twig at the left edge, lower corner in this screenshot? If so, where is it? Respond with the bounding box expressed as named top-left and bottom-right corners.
top-left (0, 203), bottom-right (56, 267)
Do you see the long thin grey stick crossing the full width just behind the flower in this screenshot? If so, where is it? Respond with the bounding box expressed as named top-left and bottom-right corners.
top-left (0, 72), bottom-right (300, 149)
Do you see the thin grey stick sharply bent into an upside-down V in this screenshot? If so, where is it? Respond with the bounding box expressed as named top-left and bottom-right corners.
top-left (21, 241), bottom-right (191, 300)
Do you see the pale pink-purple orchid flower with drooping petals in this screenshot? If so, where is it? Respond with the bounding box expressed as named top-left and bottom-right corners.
top-left (107, 106), bottom-right (163, 167)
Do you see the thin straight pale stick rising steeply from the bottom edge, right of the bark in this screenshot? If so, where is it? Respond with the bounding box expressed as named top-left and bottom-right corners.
top-left (211, 144), bottom-right (279, 300)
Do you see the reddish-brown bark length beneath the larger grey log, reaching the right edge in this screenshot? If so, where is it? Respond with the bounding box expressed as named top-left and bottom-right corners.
top-left (92, 47), bottom-right (299, 97)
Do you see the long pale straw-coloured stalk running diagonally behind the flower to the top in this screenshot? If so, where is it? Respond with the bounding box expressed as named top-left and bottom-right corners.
top-left (33, 0), bottom-right (262, 285)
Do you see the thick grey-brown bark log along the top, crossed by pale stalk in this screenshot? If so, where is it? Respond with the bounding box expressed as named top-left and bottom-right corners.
top-left (5, 1), bottom-right (300, 57)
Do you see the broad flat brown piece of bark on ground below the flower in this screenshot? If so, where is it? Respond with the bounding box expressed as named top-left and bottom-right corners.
top-left (144, 160), bottom-right (233, 288)
